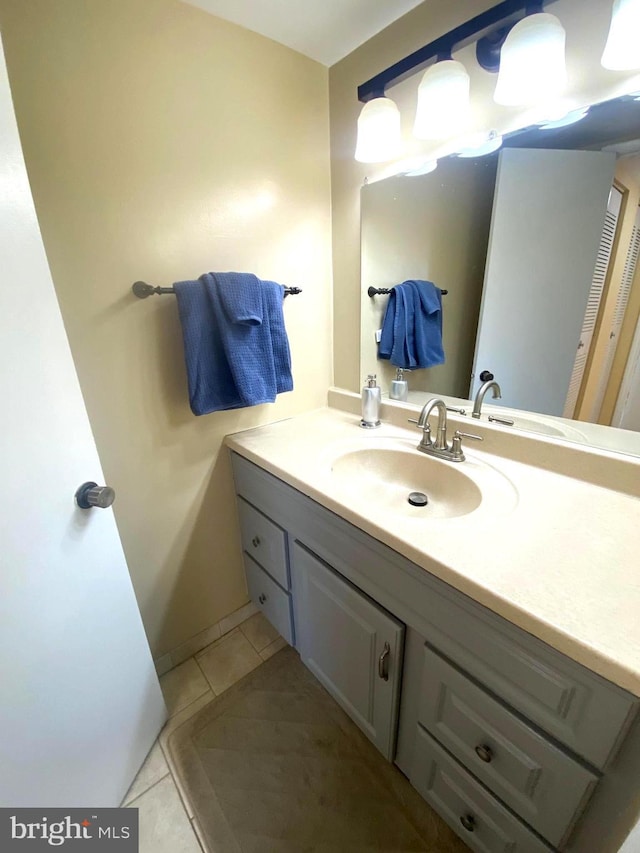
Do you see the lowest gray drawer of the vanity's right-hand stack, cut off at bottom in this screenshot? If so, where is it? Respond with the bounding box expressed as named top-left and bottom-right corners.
top-left (411, 726), bottom-right (551, 853)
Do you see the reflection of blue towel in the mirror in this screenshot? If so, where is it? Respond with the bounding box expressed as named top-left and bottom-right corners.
top-left (378, 281), bottom-right (444, 370)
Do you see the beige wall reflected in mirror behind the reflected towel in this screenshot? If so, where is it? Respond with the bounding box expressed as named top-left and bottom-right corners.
top-left (360, 156), bottom-right (498, 399)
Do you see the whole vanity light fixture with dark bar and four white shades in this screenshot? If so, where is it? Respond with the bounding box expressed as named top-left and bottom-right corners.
top-left (355, 0), bottom-right (640, 163)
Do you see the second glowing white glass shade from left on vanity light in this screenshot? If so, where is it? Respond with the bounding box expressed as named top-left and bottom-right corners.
top-left (413, 59), bottom-right (469, 139)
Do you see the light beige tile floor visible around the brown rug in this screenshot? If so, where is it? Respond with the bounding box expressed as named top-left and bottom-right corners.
top-left (123, 613), bottom-right (286, 853)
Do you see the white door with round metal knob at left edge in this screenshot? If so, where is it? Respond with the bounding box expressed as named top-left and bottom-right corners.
top-left (0, 36), bottom-right (166, 808)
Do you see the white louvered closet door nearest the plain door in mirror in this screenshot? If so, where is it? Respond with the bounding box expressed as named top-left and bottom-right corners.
top-left (562, 187), bottom-right (622, 418)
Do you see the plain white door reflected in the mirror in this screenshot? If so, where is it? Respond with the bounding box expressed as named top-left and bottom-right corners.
top-left (472, 148), bottom-right (615, 415)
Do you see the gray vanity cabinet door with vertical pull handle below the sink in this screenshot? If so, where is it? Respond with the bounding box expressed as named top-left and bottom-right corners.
top-left (292, 542), bottom-right (404, 760)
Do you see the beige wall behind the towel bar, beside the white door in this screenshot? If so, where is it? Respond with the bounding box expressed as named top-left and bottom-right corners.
top-left (0, 0), bottom-right (331, 656)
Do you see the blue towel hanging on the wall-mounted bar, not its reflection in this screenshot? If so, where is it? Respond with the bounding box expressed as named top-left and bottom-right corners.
top-left (174, 272), bottom-right (293, 415)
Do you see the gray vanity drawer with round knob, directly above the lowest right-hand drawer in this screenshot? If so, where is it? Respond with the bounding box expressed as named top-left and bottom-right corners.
top-left (418, 646), bottom-right (598, 846)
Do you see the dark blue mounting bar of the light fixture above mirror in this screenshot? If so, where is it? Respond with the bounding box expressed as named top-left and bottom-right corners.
top-left (358, 0), bottom-right (555, 103)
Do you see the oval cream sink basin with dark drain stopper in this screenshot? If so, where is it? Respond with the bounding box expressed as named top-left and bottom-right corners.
top-left (331, 439), bottom-right (516, 524)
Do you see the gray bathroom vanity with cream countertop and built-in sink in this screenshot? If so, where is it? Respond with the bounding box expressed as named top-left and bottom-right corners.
top-left (227, 402), bottom-right (640, 853)
